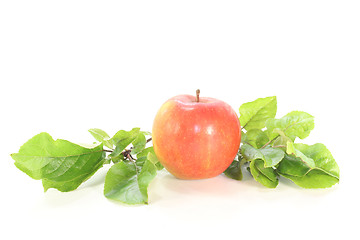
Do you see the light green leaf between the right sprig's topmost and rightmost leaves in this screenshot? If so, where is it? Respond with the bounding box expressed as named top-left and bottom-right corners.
top-left (265, 111), bottom-right (314, 141)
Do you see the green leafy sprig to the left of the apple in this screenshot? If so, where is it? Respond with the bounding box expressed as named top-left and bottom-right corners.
top-left (11, 128), bottom-right (163, 204)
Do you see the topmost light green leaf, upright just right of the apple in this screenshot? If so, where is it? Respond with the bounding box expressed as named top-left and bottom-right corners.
top-left (239, 96), bottom-right (277, 131)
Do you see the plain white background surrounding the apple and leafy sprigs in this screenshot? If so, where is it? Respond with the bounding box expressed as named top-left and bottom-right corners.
top-left (0, 0), bottom-right (360, 239)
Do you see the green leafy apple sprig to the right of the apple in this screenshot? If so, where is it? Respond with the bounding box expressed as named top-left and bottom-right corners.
top-left (225, 97), bottom-right (340, 188)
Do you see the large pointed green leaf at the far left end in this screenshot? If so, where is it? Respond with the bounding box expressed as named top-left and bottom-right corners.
top-left (11, 132), bottom-right (105, 191)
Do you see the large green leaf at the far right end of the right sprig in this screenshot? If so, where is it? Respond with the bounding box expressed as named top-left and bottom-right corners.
top-left (277, 143), bottom-right (340, 188)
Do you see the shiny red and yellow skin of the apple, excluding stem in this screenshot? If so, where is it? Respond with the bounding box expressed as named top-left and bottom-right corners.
top-left (152, 95), bottom-right (241, 179)
